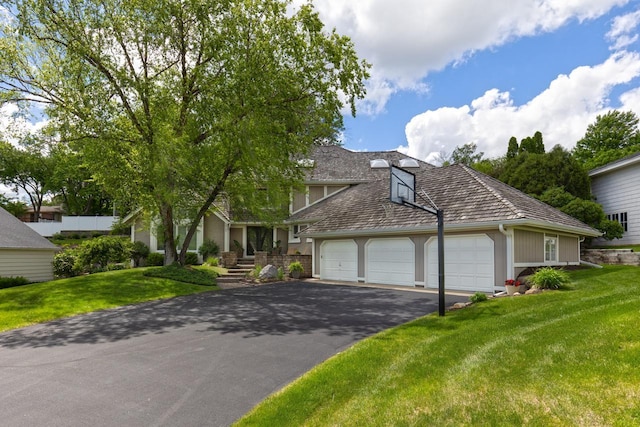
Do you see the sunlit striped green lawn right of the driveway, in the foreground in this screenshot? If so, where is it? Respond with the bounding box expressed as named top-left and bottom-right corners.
top-left (237, 266), bottom-right (640, 426)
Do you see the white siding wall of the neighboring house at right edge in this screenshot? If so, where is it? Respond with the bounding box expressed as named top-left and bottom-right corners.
top-left (591, 164), bottom-right (640, 245)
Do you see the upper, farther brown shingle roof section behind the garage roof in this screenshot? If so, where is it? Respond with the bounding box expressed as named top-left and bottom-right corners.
top-left (306, 145), bottom-right (434, 183)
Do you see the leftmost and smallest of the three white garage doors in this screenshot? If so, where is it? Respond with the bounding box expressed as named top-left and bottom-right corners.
top-left (320, 240), bottom-right (358, 282)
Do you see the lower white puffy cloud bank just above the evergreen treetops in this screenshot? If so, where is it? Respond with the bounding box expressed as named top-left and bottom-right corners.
top-left (400, 52), bottom-right (640, 163)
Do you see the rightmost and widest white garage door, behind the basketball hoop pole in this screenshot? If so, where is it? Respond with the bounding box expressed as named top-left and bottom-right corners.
top-left (425, 234), bottom-right (494, 292)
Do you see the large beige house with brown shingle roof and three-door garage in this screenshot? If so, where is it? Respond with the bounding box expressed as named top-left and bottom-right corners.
top-left (127, 146), bottom-right (600, 292)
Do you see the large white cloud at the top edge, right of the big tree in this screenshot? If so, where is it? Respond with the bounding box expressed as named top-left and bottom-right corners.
top-left (302, 0), bottom-right (628, 114)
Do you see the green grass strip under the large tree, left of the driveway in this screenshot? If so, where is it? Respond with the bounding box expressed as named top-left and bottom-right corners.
top-left (0, 268), bottom-right (215, 331)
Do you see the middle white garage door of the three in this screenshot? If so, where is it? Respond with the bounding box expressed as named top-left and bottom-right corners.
top-left (366, 238), bottom-right (416, 286)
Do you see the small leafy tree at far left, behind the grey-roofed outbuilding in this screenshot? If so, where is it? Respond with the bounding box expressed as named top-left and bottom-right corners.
top-left (0, 135), bottom-right (53, 222)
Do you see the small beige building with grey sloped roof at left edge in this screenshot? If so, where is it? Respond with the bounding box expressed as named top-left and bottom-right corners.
top-left (0, 208), bottom-right (58, 282)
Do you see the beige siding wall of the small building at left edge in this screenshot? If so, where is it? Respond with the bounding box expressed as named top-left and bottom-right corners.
top-left (0, 249), bottom-right (54, 282)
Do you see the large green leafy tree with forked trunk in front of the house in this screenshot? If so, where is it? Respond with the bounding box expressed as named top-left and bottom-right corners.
top-left (0, 0), bottom-right (368, 263)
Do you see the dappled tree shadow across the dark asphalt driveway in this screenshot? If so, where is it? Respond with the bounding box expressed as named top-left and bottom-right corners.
top-left (0, 282), bottom-right (467, 348)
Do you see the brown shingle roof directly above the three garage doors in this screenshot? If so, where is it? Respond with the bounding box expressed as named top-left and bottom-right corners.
top-left (290, 165), bottom-right (599, 236)
